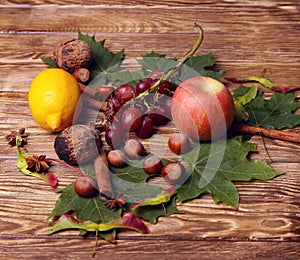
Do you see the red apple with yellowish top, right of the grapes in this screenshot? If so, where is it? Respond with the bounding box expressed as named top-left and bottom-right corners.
top-left (171, 76), bottom-right (235, 141)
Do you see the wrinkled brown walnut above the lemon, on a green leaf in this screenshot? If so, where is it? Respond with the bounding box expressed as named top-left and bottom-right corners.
top-left (53, 39), bottom-right (93, 73)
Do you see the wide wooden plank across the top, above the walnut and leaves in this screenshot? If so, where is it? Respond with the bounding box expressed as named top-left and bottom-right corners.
top-left (0, 3), bottom-right (298, 36)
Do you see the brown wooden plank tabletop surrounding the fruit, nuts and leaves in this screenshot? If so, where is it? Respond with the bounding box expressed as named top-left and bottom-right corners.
top-left (0, 0), bottom-right (300, 259)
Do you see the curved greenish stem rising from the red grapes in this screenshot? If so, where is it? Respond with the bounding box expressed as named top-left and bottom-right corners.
top-left (137, 23), bottom-right (203, 98)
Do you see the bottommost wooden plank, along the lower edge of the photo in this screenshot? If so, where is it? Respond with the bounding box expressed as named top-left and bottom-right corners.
top-left (0, 236), bottom-right (299, 260)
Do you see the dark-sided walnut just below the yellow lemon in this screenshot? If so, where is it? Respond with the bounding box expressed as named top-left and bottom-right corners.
top-left (54, 125), bottom-right (101, 165)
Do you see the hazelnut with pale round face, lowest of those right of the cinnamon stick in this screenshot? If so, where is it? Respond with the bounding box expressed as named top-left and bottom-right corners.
top-left (161, 162), bottom-right (187, 185)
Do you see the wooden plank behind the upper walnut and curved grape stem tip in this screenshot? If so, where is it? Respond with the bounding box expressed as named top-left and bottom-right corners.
top-left (0, 30), bottom-right (299, 62)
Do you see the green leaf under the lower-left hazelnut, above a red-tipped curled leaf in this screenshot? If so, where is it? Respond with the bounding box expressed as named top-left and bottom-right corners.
top-left (50, 183), bottom-right (121, 223)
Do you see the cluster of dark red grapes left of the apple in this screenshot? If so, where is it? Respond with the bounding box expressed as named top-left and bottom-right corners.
top-left (99, 72), bottom-right (176, 149)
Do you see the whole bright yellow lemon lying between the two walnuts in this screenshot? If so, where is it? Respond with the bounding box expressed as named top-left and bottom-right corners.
top-left (28, 68), bottom-right (81, 131)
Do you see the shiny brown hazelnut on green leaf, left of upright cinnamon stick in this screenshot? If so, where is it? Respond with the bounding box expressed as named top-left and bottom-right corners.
top-left (74, 176), bottom-right (98, 198)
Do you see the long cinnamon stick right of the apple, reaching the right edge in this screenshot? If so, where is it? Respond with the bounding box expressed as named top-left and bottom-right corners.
top-left (231, 123), bottom-right (300, 143)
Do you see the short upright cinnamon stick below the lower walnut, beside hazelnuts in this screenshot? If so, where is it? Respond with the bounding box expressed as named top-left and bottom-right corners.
top-left (94, 151), bottom-right (114, 198)
